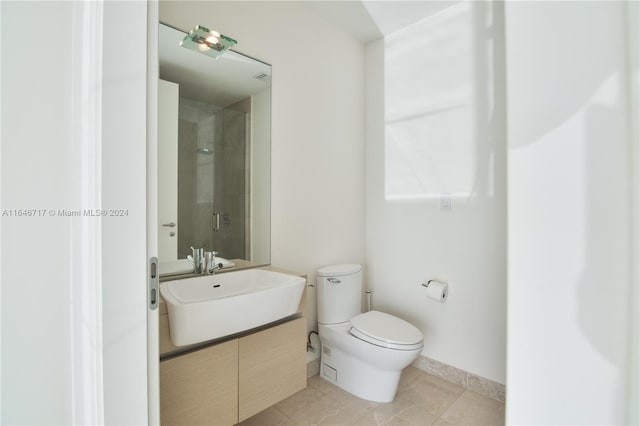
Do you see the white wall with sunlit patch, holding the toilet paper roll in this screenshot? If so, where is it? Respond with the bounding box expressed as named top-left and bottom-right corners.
top-left (366, 2), bottom-right (506, 383)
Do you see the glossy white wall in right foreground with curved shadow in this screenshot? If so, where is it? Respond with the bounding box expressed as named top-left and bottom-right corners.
top-left (506, 2), bottom-right (638, 424)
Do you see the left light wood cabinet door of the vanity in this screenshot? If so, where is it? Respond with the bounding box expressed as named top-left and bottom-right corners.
top-left (160, 339), bottom-right (238, 425)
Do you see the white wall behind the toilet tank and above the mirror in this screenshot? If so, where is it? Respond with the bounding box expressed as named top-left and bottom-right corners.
top-left (160, 1), bottom-right (364, 328)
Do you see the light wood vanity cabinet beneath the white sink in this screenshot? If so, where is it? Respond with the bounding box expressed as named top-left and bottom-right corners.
top-left (159, 266), bottom-right (307, 425)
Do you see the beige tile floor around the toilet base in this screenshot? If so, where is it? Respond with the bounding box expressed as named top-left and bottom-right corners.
top-left (241, 366), bottom-right (504, 426)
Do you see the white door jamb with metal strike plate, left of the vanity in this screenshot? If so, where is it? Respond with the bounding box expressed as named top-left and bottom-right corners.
top-left (103, 1), bottom-right (158, 425)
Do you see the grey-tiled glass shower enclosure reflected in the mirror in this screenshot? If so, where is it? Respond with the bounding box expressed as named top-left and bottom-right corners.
top-left (177, 97), bottom-right (250, 259)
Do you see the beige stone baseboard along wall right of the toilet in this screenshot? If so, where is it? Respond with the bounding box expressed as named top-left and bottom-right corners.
top-left (412, 355), bottom-right (506, 402)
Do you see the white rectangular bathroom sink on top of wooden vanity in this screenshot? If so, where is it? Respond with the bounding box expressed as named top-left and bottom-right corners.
top-left (160, 269), bottom-right (306, 346)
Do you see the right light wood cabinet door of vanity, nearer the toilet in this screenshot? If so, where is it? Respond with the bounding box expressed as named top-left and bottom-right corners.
top-left (238, 318), bottom-right (307, 421)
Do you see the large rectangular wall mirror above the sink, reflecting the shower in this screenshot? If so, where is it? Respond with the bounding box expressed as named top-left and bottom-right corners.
top-left (158, 24), bottom-right (271, 276)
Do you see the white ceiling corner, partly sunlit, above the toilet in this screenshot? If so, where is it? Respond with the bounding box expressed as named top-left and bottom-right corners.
top-left (301, 0), bottom-right (460, 44)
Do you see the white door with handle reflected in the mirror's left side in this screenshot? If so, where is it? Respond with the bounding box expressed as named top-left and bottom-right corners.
top-left (158, 80), bottom-right (179, 262)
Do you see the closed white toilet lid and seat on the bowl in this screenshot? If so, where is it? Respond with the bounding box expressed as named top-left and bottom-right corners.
top-left (349, 311), bottom-right (423, 350)
